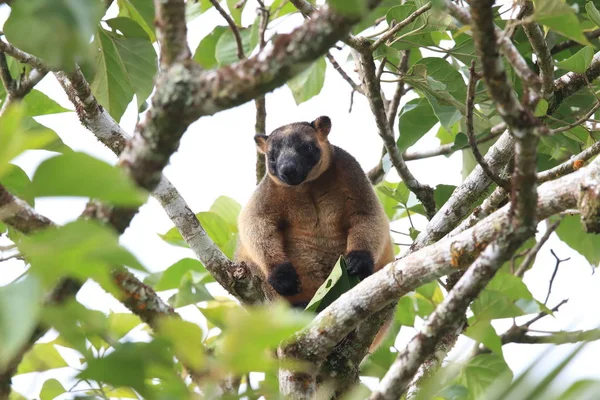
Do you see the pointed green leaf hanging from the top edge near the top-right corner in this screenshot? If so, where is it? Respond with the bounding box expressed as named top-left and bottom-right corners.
top-left (528, 0), bottom-right (590, 46)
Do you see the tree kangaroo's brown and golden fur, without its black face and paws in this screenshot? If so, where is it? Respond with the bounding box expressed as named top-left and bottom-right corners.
top-left (235, 118), bottom-right (394, 346)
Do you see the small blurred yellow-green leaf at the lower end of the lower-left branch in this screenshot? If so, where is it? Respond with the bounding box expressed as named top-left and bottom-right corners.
top-left (157, 317), bottom-right (206, 370)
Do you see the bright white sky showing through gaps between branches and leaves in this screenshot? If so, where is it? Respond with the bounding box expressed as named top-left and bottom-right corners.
top-left (0, 1), bottom-right (600, 398)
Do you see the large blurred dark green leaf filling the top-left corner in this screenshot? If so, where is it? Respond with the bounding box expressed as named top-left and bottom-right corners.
top-left (4, 0), bottom-right (104, 70)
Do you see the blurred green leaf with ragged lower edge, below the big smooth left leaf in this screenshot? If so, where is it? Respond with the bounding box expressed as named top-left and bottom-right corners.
top-left (18, 220), bottom-right (145, 290)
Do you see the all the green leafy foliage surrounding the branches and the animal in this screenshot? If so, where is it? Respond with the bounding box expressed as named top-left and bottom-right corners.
top-left (0, 0), bottom-right (600, 400)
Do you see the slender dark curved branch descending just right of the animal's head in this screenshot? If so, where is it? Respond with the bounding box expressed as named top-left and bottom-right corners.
top-left (359, 39), bottom-right (435, 218)
